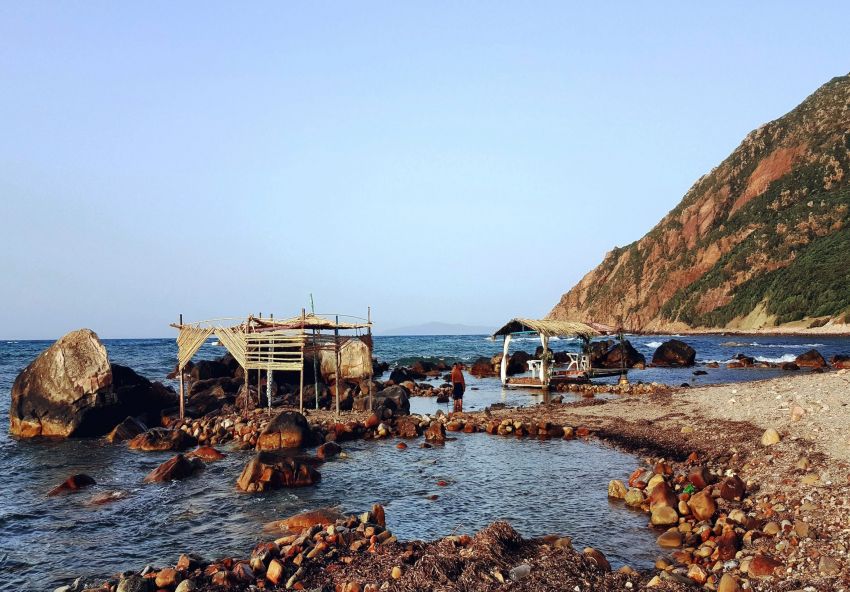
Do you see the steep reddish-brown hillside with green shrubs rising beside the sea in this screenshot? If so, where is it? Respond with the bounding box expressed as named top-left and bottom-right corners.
top-left (549, 75), bottom-right (850, 331)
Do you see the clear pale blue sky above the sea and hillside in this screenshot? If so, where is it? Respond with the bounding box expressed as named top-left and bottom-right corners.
top-left (0, 0), bottom-right (850, 339)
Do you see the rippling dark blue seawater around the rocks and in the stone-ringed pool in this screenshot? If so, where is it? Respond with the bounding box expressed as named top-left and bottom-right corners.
top-left (0, 336), bottom-right (850, 590)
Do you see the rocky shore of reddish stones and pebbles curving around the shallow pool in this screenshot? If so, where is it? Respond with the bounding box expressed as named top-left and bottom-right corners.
top-left (48, 370), bottom-right (850, 592)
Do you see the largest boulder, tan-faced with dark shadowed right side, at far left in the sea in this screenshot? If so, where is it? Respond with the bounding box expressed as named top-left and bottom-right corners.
top-left (9, 329), bottom-right (177, 438)
